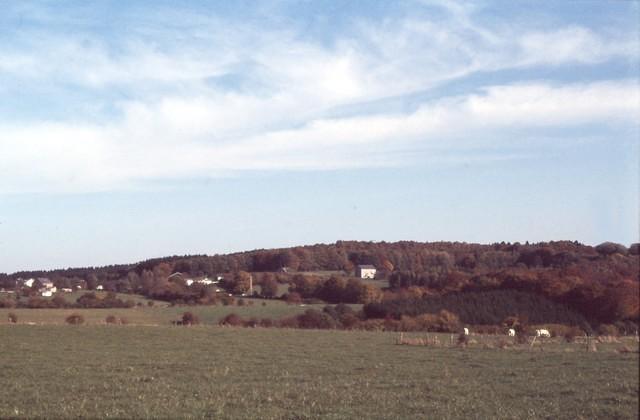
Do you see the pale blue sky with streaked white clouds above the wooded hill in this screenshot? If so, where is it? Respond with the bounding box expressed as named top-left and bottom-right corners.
top-left (0, 0), bottom-right (640, 273)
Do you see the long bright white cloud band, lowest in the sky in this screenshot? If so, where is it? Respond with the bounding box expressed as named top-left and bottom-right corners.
top-left (0, 81), bottom-right (640, 192)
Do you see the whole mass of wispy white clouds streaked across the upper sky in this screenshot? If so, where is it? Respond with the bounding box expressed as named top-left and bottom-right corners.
top-left (0, 2), bottom-right (640, 193)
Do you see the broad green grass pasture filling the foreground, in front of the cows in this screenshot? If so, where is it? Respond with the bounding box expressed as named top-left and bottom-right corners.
top-left (0, 325), bottom-right (638, 419)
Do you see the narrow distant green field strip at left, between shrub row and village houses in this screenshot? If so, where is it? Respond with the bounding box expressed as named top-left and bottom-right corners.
top-left (0, 298), bottom-right (340, 325)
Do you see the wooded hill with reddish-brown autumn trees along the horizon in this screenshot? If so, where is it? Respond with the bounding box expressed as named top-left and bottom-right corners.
top-left (0, 241), bottom-right (640, 324)
